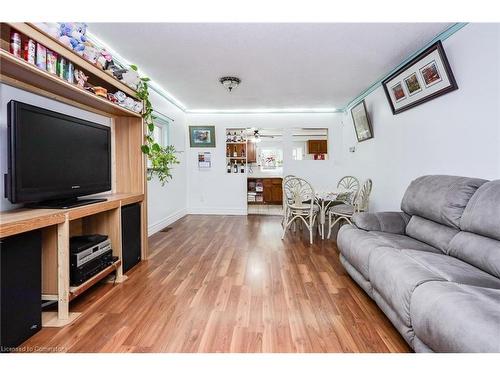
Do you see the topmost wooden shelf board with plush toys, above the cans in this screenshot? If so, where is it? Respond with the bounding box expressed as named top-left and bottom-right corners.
top-left (7, 23), bottom-right (137, 98)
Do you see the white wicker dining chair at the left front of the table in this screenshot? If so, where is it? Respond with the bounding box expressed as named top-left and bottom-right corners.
top-left (281, 177), bottom-right (319, 244)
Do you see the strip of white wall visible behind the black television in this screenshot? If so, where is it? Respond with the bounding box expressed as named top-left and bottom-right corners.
top-left (0, 84), bottom-right (111, 211)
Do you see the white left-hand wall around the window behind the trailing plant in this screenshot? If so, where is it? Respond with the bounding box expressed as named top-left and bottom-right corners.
top-left (148, 90), bottom-right (187, 235)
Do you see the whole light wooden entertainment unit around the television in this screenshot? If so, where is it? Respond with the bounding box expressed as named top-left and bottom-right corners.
top-left (0, 23), bottom-right (148, 327)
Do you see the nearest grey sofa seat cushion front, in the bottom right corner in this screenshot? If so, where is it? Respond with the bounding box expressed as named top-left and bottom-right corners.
top-left (411, 282), bottom-right (500, 352)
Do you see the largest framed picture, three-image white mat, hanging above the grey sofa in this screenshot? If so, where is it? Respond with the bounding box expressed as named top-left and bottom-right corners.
top-left (382, 41), bottom-right (458, 115)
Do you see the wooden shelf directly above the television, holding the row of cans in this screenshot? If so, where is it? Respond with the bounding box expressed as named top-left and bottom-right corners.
top-left (0, 50), bottom-right (141, 117)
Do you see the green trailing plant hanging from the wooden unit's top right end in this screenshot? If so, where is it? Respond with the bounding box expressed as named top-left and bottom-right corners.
top-left (130, 65), bottom-right (180, 186)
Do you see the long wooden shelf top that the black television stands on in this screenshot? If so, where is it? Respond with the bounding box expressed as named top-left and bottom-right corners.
top-left (0, 193), bottom-right (144, 238)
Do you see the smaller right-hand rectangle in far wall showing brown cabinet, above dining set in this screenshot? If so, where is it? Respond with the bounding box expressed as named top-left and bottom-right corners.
top-left (292, 128), bottom-right (329, 160)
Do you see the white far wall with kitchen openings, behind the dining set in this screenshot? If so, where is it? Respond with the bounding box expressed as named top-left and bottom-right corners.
top-left (186, 113), bottom-right (342, 215)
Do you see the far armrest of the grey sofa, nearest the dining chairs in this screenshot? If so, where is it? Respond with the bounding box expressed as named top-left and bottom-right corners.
top-left (352, 212), bottom-right (411, 234)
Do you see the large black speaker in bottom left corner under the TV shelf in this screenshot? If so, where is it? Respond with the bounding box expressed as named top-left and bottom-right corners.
top-left (0, 231), bottom-right (42, 352)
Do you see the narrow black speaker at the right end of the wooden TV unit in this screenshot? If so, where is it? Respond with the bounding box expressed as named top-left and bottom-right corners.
top-left (122, 203), bottom-right (141, 273)
